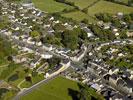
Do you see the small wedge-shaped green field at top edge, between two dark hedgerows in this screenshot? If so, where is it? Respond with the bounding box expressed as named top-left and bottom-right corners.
top-left (67, 0), bottom-right (97, 9)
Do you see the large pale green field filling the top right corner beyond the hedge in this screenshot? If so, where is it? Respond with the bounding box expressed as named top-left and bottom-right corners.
top-left (88, 0), bottom-right (133, 16)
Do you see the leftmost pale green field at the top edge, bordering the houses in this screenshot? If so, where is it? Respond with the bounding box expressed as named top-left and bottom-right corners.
top-left (32, 0), bottom-right (73, 13)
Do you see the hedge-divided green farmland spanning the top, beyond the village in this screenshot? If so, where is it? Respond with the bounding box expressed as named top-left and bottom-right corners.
top-left (33, 0), bottom-right (133, 22)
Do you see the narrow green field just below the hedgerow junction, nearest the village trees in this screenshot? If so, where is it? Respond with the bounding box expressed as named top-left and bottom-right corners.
top-left (62, 11), bottom-right (96, 22)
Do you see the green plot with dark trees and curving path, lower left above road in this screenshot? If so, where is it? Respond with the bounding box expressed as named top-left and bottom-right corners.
top-left (7, 66), bottom-right (44, 88)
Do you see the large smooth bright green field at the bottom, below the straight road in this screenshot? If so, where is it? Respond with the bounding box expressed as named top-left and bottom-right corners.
top-left (21, 77), bottom-right (104, 100)
